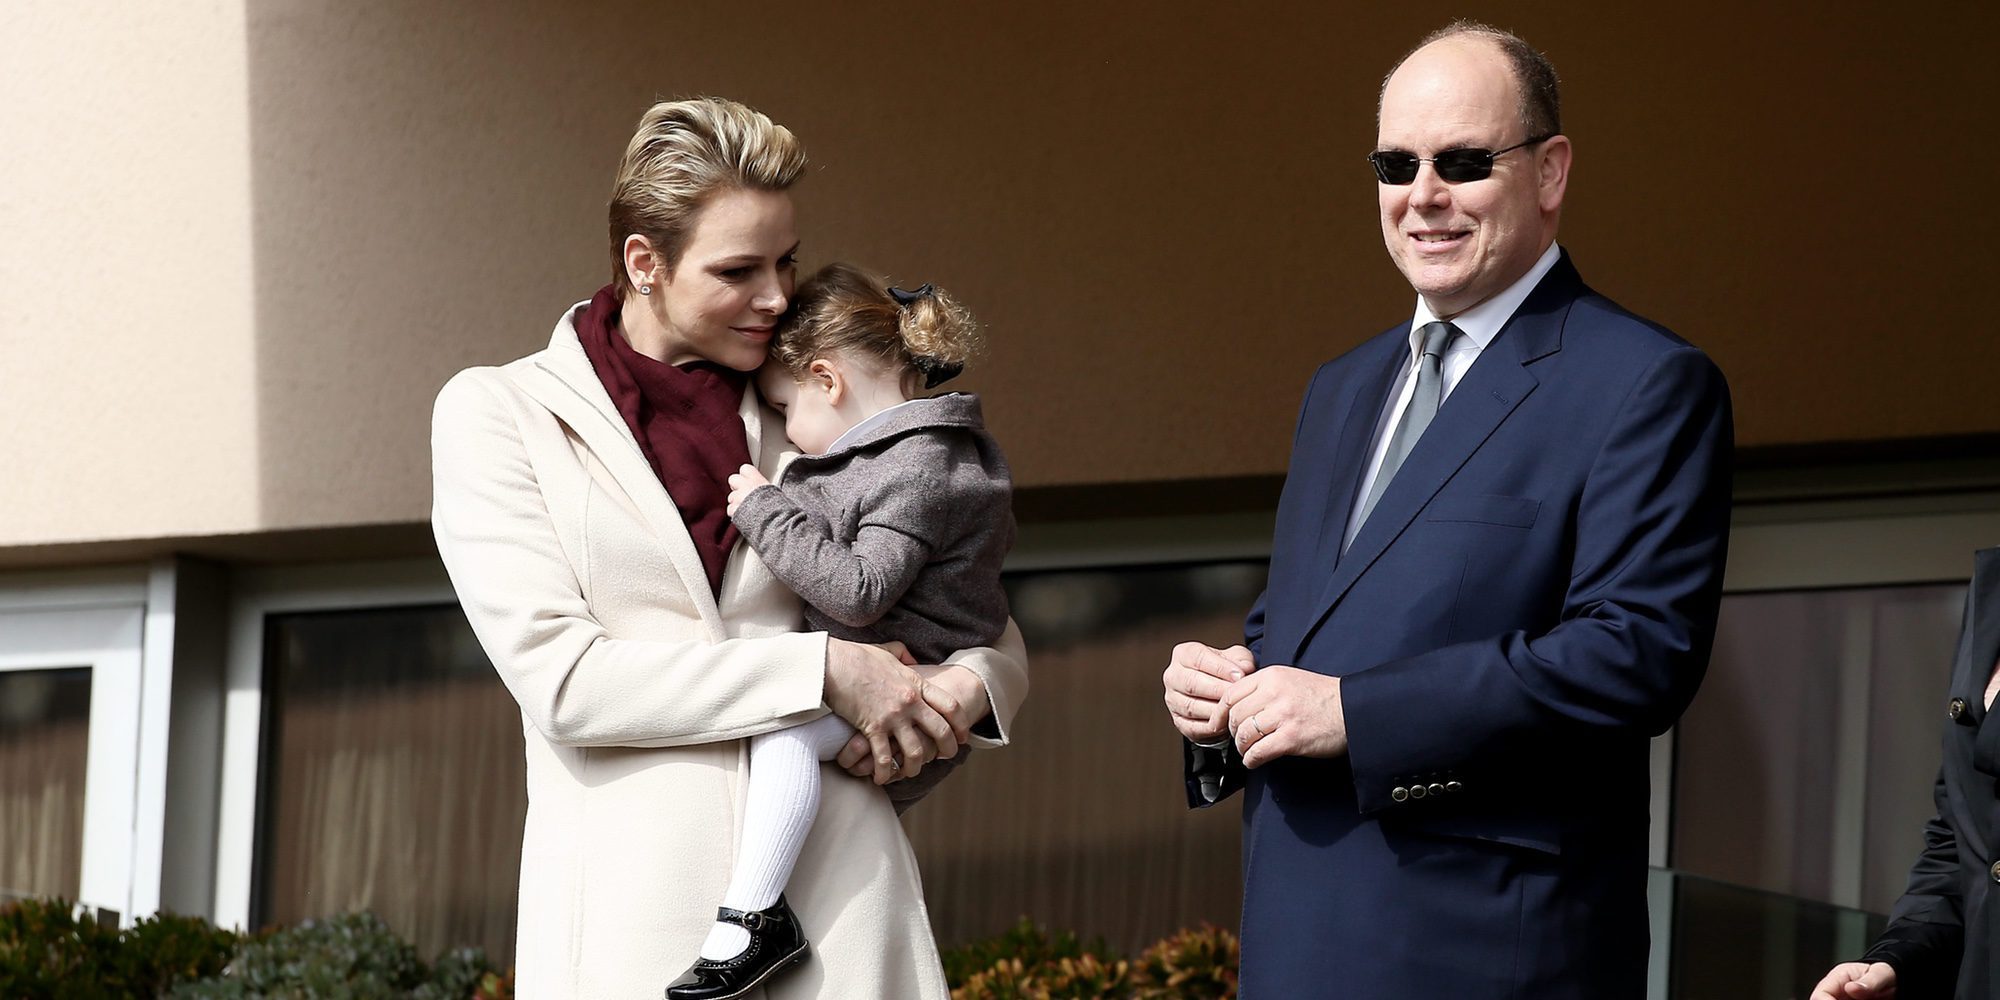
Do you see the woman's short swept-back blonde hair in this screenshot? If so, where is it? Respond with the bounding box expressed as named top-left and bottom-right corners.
top-left (608, 98), bottom-right (806, 294)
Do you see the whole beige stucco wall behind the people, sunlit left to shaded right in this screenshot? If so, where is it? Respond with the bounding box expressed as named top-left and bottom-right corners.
top-left (0, 0), bottom-right (2000, 548)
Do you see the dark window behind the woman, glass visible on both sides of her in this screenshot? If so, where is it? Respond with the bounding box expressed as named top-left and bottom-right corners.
top-left (254, 562), bottom-right (1264, 962)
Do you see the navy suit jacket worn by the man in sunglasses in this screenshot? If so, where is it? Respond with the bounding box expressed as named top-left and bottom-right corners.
top-left (1186, 254), bottom-right (1732, 1000)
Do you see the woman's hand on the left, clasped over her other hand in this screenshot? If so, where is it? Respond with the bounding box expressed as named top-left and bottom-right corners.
top-left (826, 638), bottom-right (964, 784)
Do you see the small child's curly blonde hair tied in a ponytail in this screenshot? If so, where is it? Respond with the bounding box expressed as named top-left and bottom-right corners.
top-left (770, 262), bottom-right (980, 394)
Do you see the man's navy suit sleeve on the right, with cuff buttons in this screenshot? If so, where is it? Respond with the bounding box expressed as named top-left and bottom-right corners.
top-left (1342, 348), bottom-right (1732, 812)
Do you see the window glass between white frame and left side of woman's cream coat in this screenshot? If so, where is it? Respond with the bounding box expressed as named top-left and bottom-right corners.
top-left (254, 604), bottom-right (528, 964)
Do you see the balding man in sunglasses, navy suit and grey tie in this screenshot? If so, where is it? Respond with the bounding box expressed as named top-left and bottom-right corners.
top-left (1164, 22), bottom-right (1732, 1000)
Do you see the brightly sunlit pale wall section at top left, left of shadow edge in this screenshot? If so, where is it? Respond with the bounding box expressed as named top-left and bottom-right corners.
top-left (0, 0), bottom-right (260, 548)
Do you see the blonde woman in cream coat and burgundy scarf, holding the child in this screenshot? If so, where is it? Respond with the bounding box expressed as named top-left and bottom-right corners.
top-left (432, 98), bottom-right (1028, 1000)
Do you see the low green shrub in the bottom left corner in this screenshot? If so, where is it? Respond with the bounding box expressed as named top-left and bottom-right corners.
top-left (0, 900), bottom-right (238, 1000)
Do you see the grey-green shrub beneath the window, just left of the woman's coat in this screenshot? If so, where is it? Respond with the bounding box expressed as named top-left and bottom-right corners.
top-left (170, 914), bottom-right (512, 1000)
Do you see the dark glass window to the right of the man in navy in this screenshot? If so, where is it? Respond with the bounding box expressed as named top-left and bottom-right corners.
top-left (1672, 584), bottom-right (1966, 912)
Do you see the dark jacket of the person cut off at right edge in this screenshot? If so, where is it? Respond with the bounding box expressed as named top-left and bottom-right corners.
top-left (1866, 548), bottom-right (2000, 1000)
